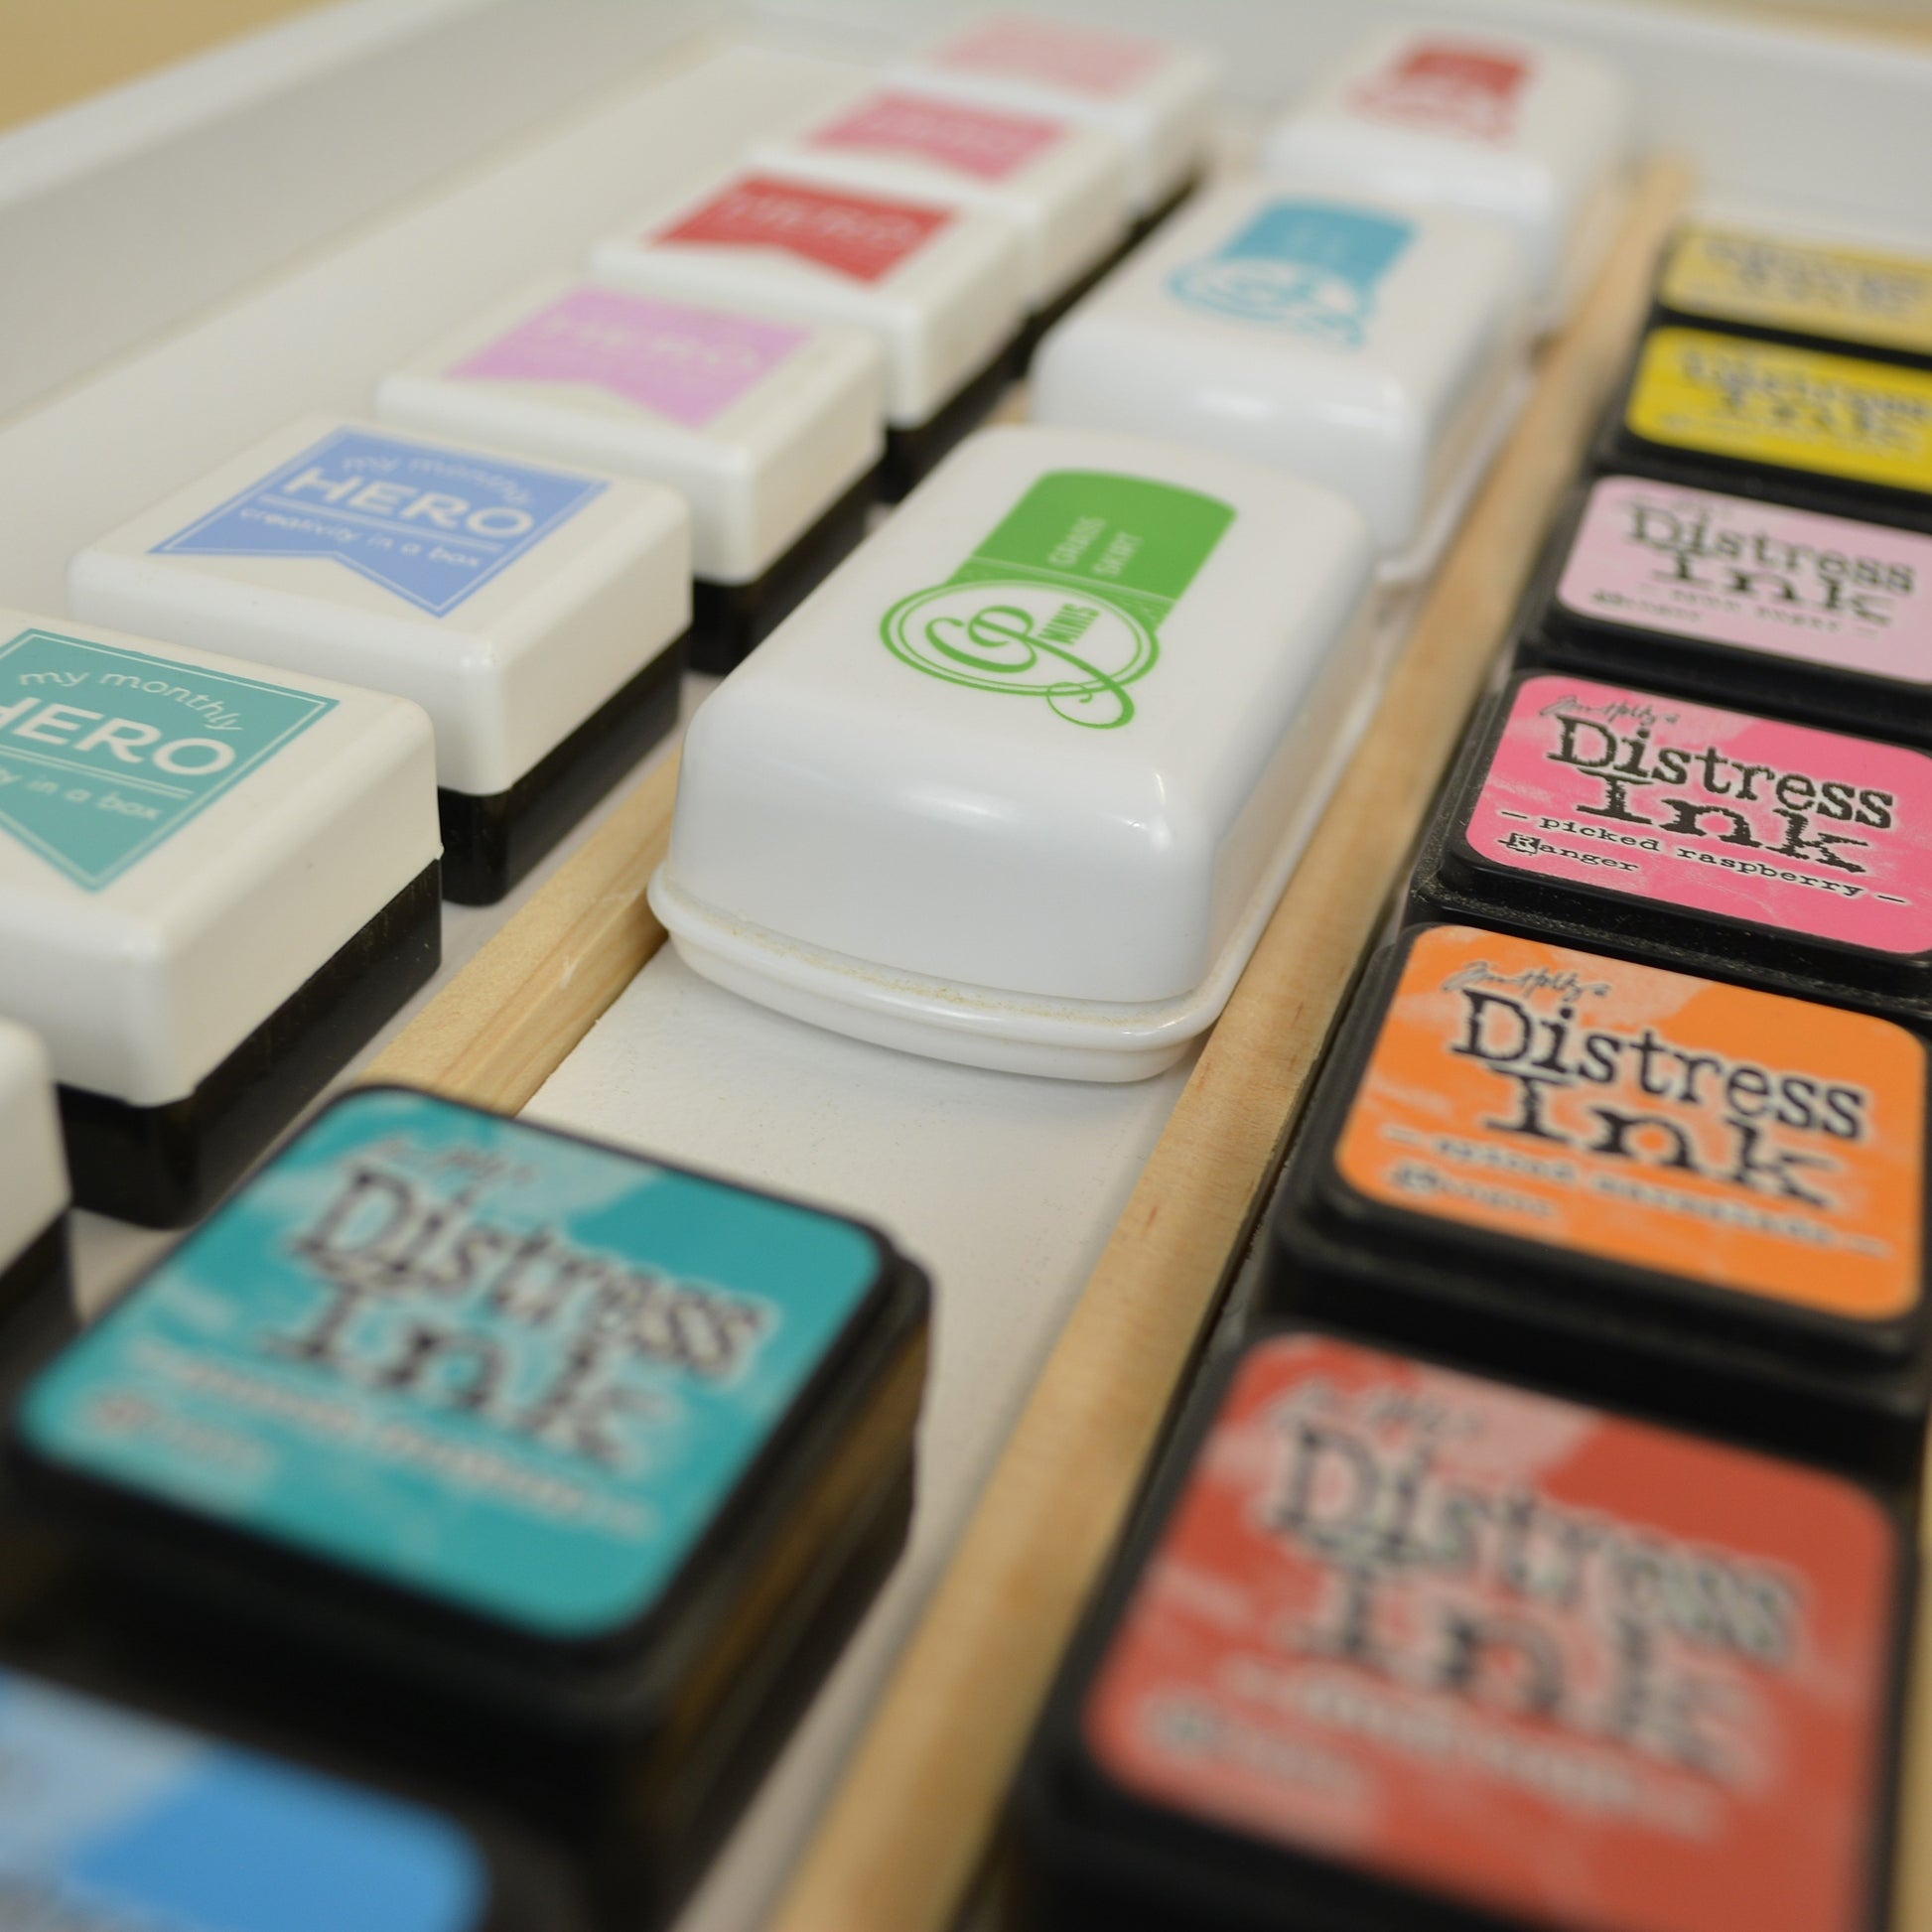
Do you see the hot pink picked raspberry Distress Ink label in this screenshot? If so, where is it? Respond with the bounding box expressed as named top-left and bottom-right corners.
top-left (1464, 676), bottom-right (1932, 952)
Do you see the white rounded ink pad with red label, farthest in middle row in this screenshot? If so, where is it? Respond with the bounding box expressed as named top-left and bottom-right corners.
top-left (1260, 25), bottom-right (1630, 329)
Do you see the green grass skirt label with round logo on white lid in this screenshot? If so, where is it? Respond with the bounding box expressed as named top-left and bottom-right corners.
top-left (879, 470), bottom-right (1234, 731)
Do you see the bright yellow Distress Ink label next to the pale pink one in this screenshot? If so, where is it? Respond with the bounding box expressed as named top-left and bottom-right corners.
top-left (1625, 329), bottom-right (1932, 494)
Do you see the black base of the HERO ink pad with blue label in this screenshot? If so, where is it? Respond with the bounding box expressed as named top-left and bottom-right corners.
top-left (437, 633), bottom-right (690, 906)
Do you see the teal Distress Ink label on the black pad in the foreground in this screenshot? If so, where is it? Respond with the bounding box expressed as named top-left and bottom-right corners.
top-left (18, 1091), bottom-right (881, 1638)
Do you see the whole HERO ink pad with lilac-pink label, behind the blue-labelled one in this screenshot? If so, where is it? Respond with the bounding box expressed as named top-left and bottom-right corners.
top-left (376, 280), bottom-right (885, 672)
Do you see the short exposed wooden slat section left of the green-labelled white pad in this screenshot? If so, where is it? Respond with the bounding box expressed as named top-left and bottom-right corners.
top-left (363, 758), bottom-right (678, 1113)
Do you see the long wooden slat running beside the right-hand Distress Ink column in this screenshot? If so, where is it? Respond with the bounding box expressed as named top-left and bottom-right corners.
top-left (772, 164), bottom-right (1689, 1932)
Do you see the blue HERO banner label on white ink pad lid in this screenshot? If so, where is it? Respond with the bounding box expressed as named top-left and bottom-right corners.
top-left (155, 429), bottom-right (603, 617)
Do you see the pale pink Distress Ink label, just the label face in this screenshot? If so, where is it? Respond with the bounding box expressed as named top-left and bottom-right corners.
top-left (1557, 478), bottom-right (1932, 684)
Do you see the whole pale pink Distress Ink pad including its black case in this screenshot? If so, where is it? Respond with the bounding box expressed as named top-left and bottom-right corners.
top-left (1517, 476), bottom-right (1932, 750)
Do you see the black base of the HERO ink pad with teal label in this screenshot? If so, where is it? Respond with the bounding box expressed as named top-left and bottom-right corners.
top-left (60, 866), bottom-right (443, 1227)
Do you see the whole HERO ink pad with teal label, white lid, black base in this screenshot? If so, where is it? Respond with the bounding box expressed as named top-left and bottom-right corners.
top-left (0, 611), bottom-right (443, 1227)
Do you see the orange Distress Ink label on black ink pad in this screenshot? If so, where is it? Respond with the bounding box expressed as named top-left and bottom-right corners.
top-left (1335, 927), bottom-right (1926, 1321)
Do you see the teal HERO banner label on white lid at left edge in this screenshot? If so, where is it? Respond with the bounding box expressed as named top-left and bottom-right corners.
top-left (0, 629), bottom-right (337, 893)
